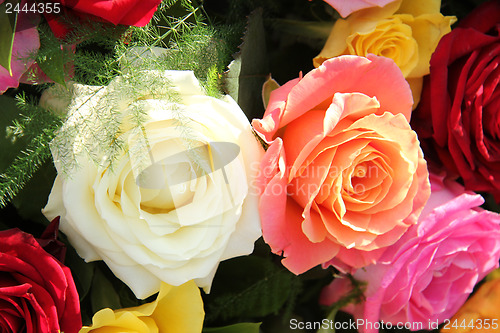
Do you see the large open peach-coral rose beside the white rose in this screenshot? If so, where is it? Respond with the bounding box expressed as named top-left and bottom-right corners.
top-left (252, 55), bottom-right (430, 274)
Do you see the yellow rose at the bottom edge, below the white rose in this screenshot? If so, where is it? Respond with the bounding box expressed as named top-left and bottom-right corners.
top-left (80, 281), bottom-right (205, 333)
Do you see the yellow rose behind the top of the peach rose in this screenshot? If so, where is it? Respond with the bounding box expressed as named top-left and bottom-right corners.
top-left (313, 0), bottom-right (456, 105)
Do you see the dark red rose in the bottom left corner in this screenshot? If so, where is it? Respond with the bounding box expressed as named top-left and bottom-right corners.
top-left (0, 229), bottom-right (82, 333)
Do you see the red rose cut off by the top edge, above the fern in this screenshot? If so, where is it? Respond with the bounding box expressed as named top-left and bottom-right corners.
top-left (45, 0), bottom-right (161, 37)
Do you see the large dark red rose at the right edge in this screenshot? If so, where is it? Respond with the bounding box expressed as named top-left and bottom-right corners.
top-left (412, 1), bottom-right (500, 201)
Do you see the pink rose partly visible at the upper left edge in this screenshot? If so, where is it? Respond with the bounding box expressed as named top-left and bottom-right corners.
top-left (0, 4), bottom-right (40, 94)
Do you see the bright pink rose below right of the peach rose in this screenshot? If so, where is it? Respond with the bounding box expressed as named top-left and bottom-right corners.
top-left (320, 172), bottom-right (500, 332)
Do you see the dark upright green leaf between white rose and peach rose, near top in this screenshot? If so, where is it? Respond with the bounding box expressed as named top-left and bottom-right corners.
top-left (224, 9), bottom-right (269, 119)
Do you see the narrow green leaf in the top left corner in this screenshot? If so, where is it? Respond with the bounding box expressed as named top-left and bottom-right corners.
top-left (0, 0), bottom-right (19, 75)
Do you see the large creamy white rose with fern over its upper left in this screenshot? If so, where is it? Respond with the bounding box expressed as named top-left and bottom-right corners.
top-left (43, 71), bottom-right (264, 298)
